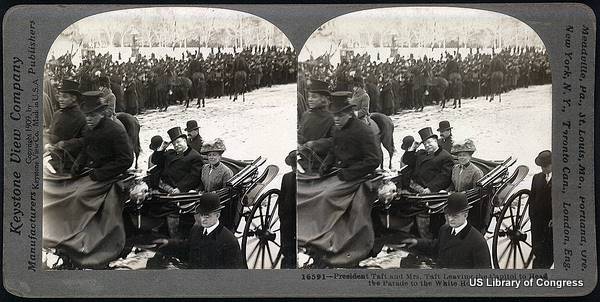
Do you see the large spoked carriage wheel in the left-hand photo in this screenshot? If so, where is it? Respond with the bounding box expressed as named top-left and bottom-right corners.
top-left (242, 189), bottom-right (282, 269)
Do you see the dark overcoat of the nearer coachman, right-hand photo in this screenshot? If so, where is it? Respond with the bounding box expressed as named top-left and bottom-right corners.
top-left (324, 117), bottom-right (380, 181)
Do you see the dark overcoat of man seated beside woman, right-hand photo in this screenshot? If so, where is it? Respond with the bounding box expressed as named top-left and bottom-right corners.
top-left (402, 148), bottom-right (454, 192)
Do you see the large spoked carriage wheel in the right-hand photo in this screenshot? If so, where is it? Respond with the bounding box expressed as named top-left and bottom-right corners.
top-left (492, 189), bottom-right (533, 269)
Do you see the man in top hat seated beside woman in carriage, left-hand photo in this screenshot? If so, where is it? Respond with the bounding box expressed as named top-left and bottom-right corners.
top-left (152, 127), bottom-right (204, 237)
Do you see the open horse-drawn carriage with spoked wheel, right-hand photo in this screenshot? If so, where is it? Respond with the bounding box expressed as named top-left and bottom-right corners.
top-left (298, 158), bottom-right (533, 269)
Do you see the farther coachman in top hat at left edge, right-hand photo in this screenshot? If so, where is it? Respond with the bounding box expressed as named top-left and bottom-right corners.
top-left (298, 79), bottom-right (333, 170)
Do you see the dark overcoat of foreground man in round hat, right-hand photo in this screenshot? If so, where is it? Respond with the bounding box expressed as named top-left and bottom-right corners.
top-left (416, 224), bottom-right (492, 269)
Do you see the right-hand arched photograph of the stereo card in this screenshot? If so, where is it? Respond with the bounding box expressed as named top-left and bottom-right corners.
top-left (296, 7), bottom-right (554, 269)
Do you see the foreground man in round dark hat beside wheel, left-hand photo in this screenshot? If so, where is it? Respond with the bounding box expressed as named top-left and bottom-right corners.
top-left (155, 192), bottom-right (246, 269)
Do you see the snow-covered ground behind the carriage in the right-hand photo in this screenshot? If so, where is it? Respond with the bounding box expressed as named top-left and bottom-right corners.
top-left (361, 85), bottom-right (552, 268)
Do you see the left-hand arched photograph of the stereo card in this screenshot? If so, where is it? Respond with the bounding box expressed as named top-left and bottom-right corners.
top-left (42, 7), bottom-right (297, 270)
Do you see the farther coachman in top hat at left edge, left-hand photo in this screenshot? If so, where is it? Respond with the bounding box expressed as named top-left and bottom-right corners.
top-left (45, 80), bottom-right (86, 173)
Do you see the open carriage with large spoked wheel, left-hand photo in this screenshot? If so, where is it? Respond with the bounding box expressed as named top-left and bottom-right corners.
top-left (125, 157), bottom-right (282, 268)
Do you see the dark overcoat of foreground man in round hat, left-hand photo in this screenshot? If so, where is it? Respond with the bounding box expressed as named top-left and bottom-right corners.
top-left (161, 224), bottom-right (246, 269)
